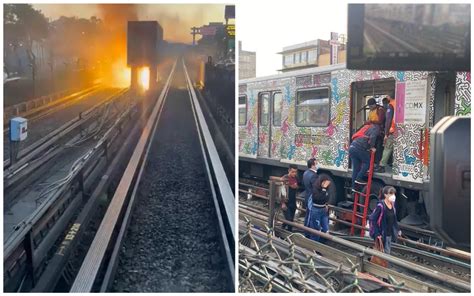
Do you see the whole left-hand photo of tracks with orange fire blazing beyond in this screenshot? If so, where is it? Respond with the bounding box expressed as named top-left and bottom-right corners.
top-left (3, 4), bottom-right (236, 292)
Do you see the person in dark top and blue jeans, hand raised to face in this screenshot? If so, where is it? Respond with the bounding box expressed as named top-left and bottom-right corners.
top-left (305, 176), bottom-right (331, 242)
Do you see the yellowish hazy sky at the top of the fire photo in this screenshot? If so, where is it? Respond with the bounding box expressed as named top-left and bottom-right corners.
top-left (33, 4), bottom-right (225, 43)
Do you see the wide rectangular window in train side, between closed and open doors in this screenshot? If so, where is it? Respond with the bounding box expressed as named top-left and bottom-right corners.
top-left (296, 88), bottom-right (330, 126)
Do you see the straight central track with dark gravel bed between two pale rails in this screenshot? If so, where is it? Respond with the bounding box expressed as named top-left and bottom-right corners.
top-left (70, 57), bottom-right (235, 292)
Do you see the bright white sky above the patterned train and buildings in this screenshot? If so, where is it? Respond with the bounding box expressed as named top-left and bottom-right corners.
top-left (241, 0), bottom-right (347, 76)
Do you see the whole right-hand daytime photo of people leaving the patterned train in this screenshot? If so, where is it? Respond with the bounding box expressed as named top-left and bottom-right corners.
top-left (236, 1), bottom-right (471, 293)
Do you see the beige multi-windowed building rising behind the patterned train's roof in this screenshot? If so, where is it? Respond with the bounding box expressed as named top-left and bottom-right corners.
top-left (278, 33), bottom-right (346, 72)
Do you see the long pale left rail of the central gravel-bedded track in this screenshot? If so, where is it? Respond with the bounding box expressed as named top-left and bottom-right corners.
top-left (70, 61), bottom-right (180, 293)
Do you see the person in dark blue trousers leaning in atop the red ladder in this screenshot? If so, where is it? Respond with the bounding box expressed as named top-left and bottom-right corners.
top-left (349, 122), bottom-right (381, 191)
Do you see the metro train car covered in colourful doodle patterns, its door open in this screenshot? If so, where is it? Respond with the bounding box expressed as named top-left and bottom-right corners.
top-left (239, 64), bottom-right (471, 224)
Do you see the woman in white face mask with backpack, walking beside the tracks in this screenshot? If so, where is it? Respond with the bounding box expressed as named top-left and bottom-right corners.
top-left (369, 186), bottom-right (402, 254)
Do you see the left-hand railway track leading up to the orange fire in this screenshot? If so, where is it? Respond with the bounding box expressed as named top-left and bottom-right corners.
top-left (4, 89), bottom-right (136, 291)
